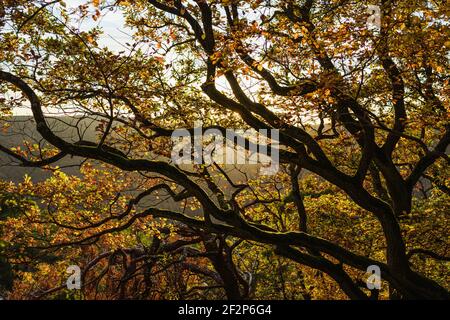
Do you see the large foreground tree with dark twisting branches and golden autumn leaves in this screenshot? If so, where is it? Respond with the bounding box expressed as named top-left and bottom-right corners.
top-left (0, 0), bottom-right (450, 299)
